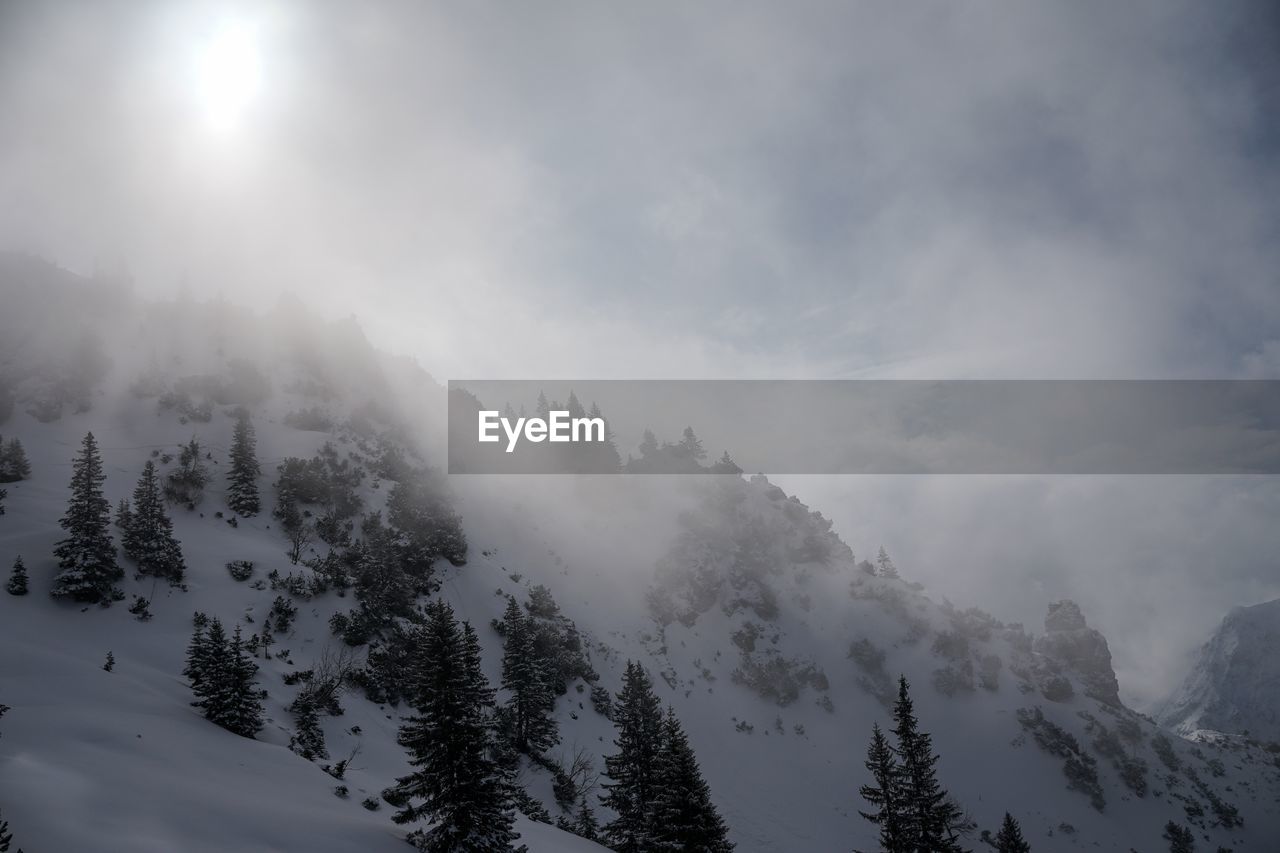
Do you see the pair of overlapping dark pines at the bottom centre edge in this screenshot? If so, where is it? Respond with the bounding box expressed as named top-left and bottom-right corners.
top-left (600, 661), bottom-right (733, 853)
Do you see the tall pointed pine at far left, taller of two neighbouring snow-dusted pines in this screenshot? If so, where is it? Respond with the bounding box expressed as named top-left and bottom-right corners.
top-left (51, 433), bottom-right (124, 602)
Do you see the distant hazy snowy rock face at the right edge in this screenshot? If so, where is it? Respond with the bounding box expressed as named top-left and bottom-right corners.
top-left (1156, 598), bottom-right (1280, 742)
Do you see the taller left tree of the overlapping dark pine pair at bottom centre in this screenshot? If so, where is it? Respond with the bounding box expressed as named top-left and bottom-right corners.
top-left (600, 661), bottom-right (662, 853)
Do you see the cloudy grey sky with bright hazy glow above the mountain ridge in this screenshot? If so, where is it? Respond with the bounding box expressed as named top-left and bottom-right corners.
top-left (0, 0), bottom-right (1280, 701)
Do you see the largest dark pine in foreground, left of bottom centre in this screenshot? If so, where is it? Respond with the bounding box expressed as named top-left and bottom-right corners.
top-left (389, 599), bottom-right (517, 853)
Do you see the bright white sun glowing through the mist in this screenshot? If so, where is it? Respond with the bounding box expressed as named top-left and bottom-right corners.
top-left (196, 22), bottom-right (262, 131)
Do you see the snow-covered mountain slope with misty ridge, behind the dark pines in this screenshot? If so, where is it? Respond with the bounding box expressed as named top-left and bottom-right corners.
top-left (0, 257), bottom-right (1280, 853)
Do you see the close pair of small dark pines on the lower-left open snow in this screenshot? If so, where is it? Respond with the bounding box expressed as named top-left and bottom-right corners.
top-left (182, 613), bottom-right (262, 738)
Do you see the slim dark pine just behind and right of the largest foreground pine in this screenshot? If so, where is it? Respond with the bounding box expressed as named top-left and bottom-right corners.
top-left (498, 597), bottom-right (559, 756)
